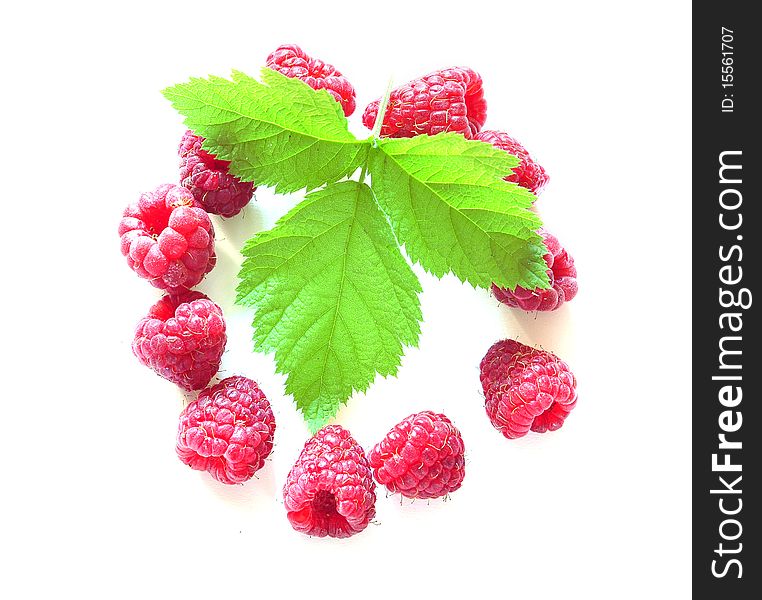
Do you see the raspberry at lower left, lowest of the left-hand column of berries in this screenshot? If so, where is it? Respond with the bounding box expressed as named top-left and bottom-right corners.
top-left (177, 377), bottom-right (275, 484)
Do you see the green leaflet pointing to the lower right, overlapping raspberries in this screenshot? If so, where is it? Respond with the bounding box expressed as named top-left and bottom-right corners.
top-left (369, 133), bottom-right (549, 289)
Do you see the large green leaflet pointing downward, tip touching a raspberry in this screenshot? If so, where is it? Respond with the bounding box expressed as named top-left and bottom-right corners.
top-left (236, 181), bottom-right (421, 431)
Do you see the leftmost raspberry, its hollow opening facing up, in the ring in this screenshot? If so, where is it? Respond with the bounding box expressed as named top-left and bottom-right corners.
top-left (119, 184), bottom-right (217, 293)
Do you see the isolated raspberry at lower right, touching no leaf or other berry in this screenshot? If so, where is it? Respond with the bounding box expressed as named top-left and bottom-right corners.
top-left (480, 340), bottom-right (577, 439)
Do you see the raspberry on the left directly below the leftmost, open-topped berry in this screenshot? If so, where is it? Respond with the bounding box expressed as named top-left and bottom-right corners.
top-left (132, 292), bottom-right (227, 391)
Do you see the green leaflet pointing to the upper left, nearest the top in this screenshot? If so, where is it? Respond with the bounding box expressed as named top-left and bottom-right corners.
top-left (162, 68), bottom-right (370, 193)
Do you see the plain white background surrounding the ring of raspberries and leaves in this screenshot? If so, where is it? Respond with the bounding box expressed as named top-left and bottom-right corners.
top-left (0, 1), bottom-right (691, 599)
